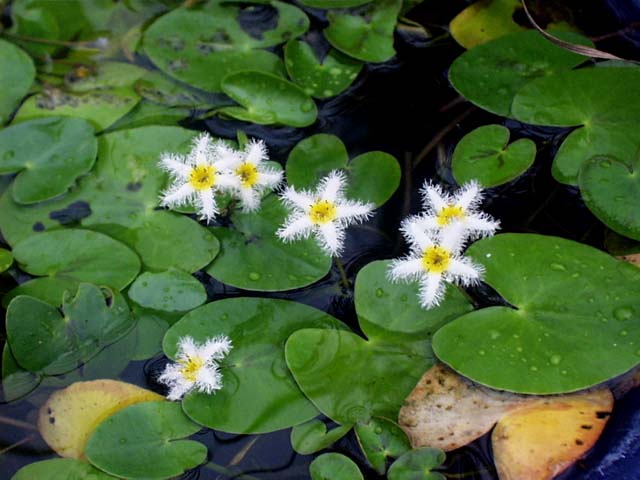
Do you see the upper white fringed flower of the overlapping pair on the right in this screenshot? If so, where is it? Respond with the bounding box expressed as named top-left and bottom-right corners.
top-left (417, 181), bottom-right (500, 239)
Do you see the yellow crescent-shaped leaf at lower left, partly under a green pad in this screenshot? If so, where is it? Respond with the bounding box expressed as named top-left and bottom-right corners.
top-left (38, 380), bottom-right (164, 459)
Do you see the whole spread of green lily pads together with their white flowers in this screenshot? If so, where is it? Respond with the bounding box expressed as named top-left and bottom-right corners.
top-left (0, 0), bottom-right (640, 480)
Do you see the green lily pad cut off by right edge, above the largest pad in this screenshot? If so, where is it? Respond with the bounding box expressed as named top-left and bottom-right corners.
top-left (580, 156), bottom-right (640, 240)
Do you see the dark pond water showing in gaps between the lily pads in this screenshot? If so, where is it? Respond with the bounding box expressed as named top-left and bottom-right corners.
top-left (0, 0), bottom-right (640, 480)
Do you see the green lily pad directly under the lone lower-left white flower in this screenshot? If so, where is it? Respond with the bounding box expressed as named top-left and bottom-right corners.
top-left (163, 298), bottom-right (345, 433)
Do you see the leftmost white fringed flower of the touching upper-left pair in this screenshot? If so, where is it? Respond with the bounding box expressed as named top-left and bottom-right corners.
top-left (160, 133), bottom-right (234, 221)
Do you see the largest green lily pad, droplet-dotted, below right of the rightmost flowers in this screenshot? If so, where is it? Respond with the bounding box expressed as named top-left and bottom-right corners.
top-left (433, 234), bottom-right (640, 394)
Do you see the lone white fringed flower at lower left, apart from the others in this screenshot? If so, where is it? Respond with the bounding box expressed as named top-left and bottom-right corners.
top-left (158, 335), bottom-right (232, 400)
